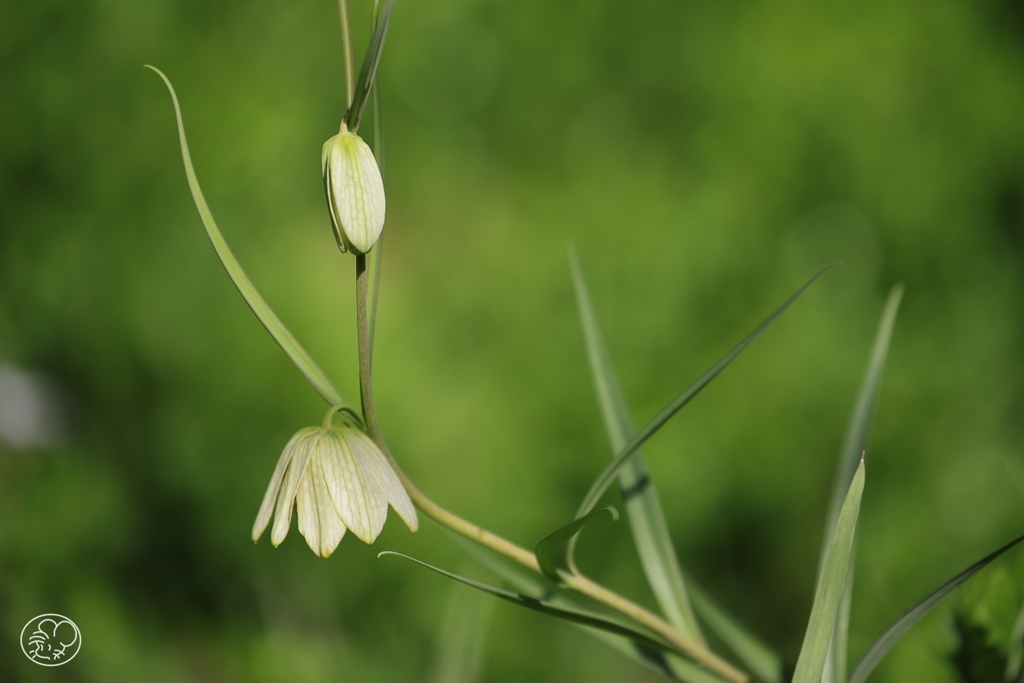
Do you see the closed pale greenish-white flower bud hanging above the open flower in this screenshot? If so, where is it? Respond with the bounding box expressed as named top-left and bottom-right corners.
top-left (321, 124), bottom-right (384, 254)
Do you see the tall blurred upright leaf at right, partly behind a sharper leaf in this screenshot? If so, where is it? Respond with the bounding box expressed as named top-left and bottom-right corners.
top-left (818, 285), bottom-right (903, 683)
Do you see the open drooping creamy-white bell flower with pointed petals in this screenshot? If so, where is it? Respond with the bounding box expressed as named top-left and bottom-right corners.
top-left (252, 414), bottom-right (419, 557)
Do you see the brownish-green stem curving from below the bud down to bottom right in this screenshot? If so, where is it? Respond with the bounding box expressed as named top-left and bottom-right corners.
top-left (355, 254), bottom-right (748, 683)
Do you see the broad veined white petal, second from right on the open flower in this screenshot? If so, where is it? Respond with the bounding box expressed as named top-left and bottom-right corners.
top-left (324, 429), bottom-right (387, 543)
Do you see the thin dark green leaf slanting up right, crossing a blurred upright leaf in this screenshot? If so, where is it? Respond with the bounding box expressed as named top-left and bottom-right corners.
top-left (577, 261), bottom-right (839, 517)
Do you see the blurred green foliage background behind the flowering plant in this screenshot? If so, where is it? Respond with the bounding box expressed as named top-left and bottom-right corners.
top-left (0, 0), bottom-right (1024, 683)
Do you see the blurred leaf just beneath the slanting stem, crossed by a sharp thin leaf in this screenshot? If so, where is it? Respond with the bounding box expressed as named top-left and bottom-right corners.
top-left (449, 532), bottom-right (725, 683)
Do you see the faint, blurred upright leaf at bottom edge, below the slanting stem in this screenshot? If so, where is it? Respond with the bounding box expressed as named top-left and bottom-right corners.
top-left (431, 558), bottom-right (495, 683)
